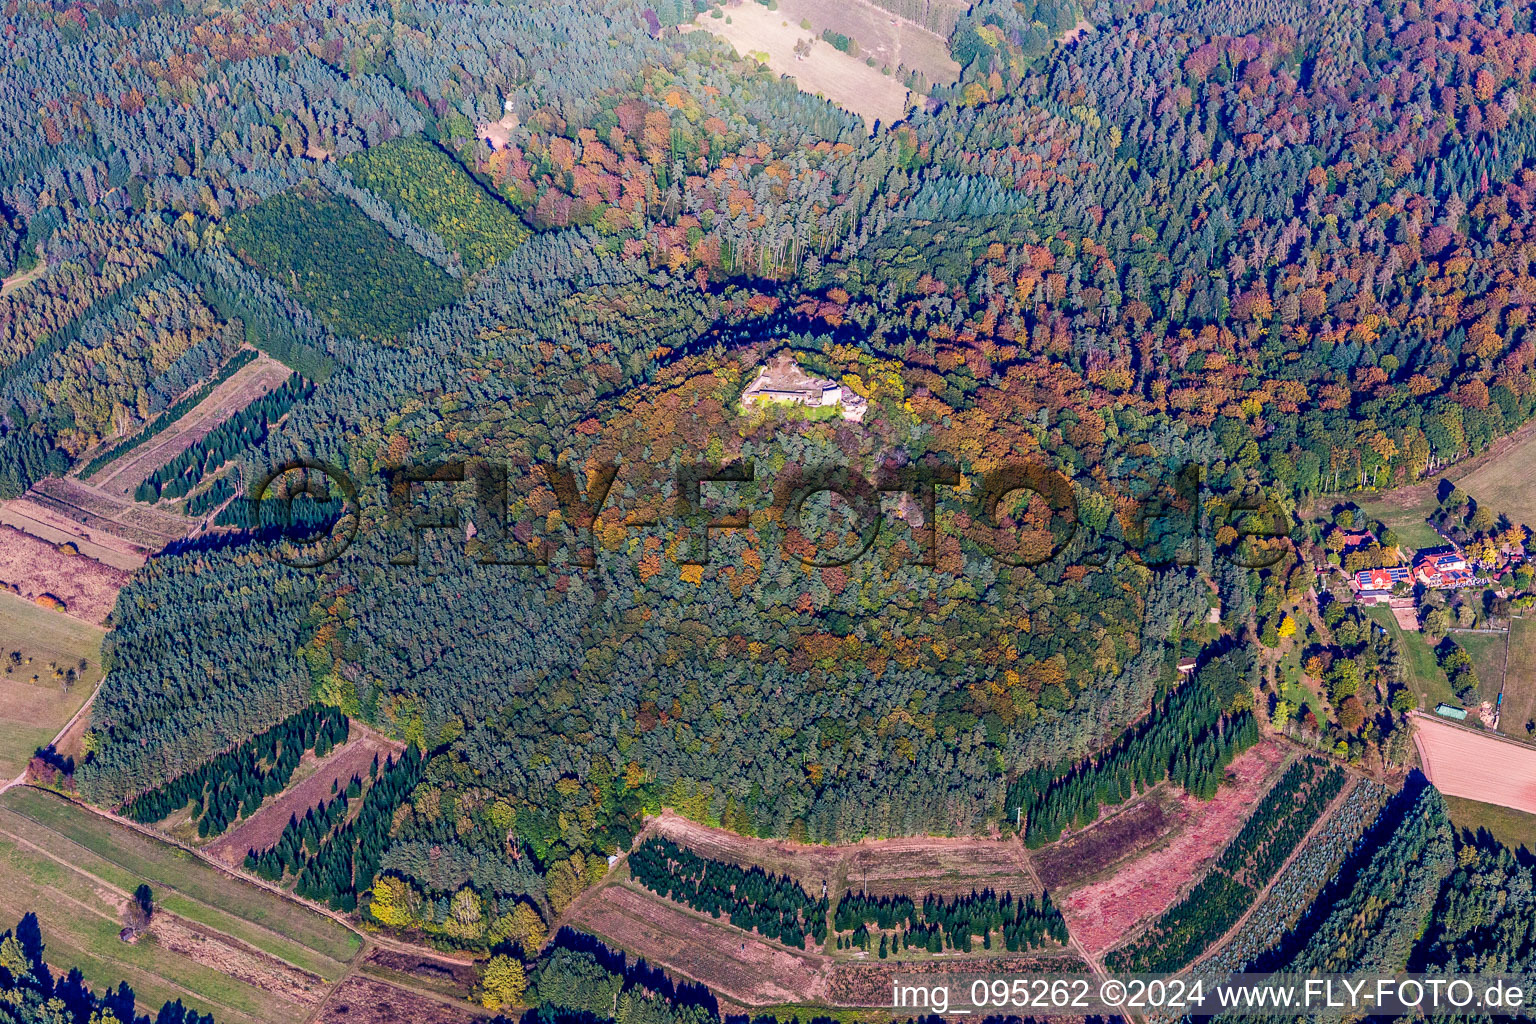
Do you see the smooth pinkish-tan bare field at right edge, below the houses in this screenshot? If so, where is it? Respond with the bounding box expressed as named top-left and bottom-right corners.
top-left (1413, 714), bottom-right (1536, 814)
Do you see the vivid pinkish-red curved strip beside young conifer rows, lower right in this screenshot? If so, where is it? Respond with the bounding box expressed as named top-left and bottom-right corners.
top-left (1052, 742), bottom-right (1286, 956)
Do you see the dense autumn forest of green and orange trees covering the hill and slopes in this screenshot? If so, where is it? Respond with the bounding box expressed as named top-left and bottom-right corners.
top-left (0, 0), bottom-right (1536, 964)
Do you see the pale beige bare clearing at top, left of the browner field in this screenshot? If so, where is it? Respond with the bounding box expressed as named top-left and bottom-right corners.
top-left (694, 3), bottom-right (908, 130)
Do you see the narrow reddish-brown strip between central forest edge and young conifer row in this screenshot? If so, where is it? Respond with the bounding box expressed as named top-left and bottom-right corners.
top-left (651, 811), bottom-right (1038, 900)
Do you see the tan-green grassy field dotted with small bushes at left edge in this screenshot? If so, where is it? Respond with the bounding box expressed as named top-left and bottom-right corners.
top-left (0, 593), bottom-right (104, 780)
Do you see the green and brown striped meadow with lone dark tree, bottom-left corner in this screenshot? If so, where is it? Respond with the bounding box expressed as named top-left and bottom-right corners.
top-left (0, 789), bottom-right (361, 1024)
